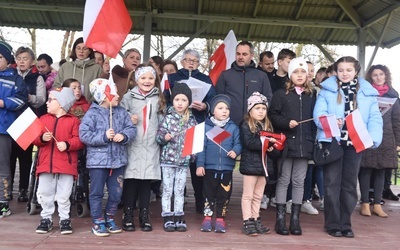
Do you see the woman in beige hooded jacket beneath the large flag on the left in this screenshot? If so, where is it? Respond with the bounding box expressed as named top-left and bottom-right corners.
top-left (53, 37), bottom-right (103, 100)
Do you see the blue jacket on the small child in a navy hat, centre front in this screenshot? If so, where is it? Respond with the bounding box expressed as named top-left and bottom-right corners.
top-left (197, 118), bottom-right (242, 171)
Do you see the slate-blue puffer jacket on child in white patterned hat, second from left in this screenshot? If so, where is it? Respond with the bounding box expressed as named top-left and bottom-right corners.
top-left (79, 103), bottom-right (136, 168)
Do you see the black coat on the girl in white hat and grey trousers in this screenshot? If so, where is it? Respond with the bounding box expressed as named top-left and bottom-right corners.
top-left (268, 89), bottom-right (317, 159)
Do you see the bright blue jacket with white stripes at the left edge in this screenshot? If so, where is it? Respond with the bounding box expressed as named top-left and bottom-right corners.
top-left (0, 68), bottom-right (28, 134)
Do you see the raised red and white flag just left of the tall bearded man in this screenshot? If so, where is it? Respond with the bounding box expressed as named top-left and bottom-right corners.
top-left (210, 30), bottom-right (237, 86)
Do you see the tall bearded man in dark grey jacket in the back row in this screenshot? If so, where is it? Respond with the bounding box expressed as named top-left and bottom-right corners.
top-left (215, 41), bottom-right (272, 125)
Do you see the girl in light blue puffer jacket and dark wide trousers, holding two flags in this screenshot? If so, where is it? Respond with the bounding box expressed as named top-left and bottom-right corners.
top-left (314, 56), bottom-right (383, 238)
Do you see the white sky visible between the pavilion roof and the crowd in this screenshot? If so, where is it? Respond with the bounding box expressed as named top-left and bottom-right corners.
top-left (0, 27), bottom-right (400, 91)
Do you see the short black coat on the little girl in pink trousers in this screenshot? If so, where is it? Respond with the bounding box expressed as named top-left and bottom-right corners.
top-left (239, 121), bottom-right (280, 176)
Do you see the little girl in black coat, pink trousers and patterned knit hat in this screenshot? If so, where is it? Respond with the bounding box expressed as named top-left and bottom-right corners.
top-left (239, 92), bottom-right (279, 236)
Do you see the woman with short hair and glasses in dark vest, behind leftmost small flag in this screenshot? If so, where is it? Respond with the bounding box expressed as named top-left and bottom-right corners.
top-left (9, 47), bottom-right (47, 202)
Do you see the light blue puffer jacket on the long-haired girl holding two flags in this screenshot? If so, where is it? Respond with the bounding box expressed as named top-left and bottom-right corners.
top-left (314, 76), bottom-right (383, 148)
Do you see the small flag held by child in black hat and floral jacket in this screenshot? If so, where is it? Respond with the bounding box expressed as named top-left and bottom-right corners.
top-left (182, 122), bottom-right (205, 157)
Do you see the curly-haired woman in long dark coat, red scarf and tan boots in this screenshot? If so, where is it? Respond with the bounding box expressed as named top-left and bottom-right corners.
top-left (358, 64), bottom-right (400, 218)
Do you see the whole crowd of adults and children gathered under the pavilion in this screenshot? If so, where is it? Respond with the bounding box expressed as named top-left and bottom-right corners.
top-left (0, 38), bottom-right (400, 238)
